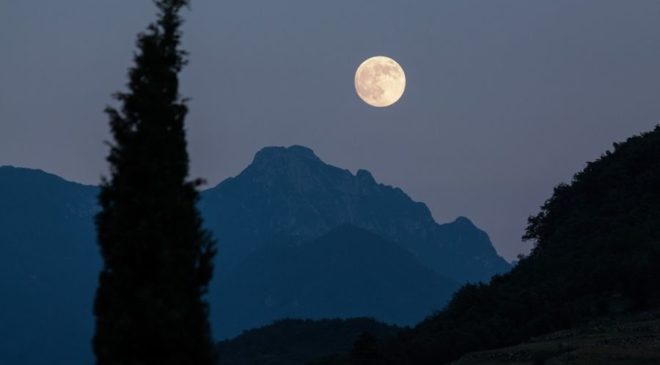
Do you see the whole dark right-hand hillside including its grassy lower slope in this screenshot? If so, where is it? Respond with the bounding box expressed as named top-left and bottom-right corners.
top-left (306, 127), bottom-right (660, 365)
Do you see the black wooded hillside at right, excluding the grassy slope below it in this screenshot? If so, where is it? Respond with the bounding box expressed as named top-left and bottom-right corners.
top-left (336, 128), bottom-right (660, 364)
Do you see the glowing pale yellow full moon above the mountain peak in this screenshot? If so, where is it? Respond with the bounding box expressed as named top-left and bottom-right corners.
top-left (355, 56), bottom-right (406, 108)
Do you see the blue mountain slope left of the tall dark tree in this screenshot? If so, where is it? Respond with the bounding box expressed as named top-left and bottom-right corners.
top-left (0, 167), bottom-right (101, 365)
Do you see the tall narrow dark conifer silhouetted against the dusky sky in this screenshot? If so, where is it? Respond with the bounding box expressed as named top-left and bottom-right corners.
top-left (93, 0), bottom-right (215, 365)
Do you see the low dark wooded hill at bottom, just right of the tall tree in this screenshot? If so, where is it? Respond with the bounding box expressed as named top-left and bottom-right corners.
top-left (218, 318), bottom-right (401, 365)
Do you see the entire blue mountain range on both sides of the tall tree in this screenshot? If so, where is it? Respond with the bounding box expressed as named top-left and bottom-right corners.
top-left (0, 146), bottom-right (509, 365)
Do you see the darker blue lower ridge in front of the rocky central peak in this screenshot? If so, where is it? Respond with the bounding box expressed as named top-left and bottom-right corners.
top-left (214, 225), bottom-right (458, 338)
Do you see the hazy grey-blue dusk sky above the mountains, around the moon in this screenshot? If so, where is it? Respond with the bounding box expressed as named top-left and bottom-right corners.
top-left (0, 0), bottom-right (660, 259)
